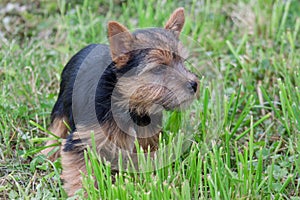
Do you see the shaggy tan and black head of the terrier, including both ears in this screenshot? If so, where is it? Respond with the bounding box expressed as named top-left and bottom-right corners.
top-left (108, 8), bottom-right (198, 115)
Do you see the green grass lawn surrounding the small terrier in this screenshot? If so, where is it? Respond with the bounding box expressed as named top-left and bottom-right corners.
top-left (0, 0), bottom-right (300, 200)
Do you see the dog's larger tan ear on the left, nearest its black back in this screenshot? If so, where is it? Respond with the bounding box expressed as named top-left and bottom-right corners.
top-left (107, 21), bottom-right (132, 68)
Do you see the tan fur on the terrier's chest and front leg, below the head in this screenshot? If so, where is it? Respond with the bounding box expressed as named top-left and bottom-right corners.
top-left (61, 123), bottom-right (159, 196)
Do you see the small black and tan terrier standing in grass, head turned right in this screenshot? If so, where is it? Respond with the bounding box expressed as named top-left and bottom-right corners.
top-left (43, 8), bottom-right (198, 196)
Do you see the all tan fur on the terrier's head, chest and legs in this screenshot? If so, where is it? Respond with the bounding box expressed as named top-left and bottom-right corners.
top-left (43, 8), bottom-right (198, 196)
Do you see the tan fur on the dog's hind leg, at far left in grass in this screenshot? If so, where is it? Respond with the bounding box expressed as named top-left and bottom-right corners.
top-left (41, 117), bottom-right (68, 161)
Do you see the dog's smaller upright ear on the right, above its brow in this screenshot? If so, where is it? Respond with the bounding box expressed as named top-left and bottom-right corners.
top-left (165, 8), bottom-right (184, 37)
